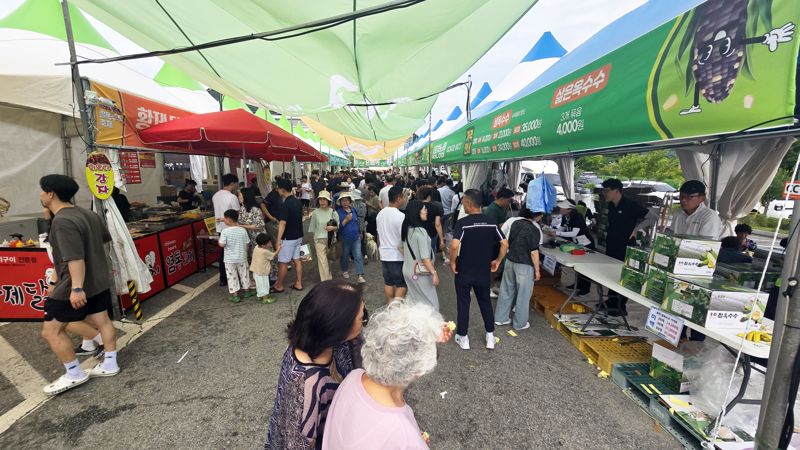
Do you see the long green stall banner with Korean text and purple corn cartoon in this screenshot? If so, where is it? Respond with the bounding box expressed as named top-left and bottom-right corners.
top-left (432, 0), bottom-right (800, 165)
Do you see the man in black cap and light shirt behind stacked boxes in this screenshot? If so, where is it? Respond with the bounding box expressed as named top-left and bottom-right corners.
top-left (670, 180), bottom-right (722, 239)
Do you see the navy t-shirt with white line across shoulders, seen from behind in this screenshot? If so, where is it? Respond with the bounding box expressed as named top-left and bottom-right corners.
top-left (453, 214), bottom-right (506, 278)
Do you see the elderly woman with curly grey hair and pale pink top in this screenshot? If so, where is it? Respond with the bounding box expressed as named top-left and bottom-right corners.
top-left (322, 299), bottom-right (452, 449)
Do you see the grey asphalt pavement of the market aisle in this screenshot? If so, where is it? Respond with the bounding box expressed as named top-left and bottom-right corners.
top-left (0, 243), bottom-right (681, 449)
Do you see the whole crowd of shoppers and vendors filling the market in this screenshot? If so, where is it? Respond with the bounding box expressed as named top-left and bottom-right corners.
top-left (29, 166), bottom-right (754, 449)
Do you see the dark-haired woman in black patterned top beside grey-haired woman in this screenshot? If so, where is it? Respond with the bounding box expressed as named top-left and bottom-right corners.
top-left (264, 279), bottom-right (367, 450)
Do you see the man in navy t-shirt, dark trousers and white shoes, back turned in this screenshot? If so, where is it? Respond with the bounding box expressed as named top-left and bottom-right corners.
top-left (450, 189), bottom-right (508, 350)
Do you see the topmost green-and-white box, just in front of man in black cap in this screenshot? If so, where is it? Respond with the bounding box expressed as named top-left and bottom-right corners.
top-left (649, 234), bottom-right (720, 277)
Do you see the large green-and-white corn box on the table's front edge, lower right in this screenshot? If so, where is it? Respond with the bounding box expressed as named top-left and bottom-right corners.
top-left (661, 276), bottom-right (769, 330)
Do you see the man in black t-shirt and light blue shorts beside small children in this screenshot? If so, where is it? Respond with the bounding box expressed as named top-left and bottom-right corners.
top-left (272, 179), bottom-right (303, 293)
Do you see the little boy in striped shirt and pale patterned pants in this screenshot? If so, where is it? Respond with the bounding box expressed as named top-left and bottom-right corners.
top-left (219, 209), bottom-right (254, 303)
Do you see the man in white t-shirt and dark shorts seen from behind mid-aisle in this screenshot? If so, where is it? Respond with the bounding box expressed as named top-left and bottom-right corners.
top-left (376, 186), bottom-right (406, 302)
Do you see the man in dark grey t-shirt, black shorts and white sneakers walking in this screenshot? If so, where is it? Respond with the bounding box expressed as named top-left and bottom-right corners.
top-left (39, 175), bottom-right (119, 395)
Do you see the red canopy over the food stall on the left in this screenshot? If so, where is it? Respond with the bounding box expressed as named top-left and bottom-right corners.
top-left (139, 109), bottom-right (328, 162)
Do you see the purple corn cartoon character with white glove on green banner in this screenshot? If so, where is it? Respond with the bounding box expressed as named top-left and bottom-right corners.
top-left (678, 0), bottom-right (795, 116)
